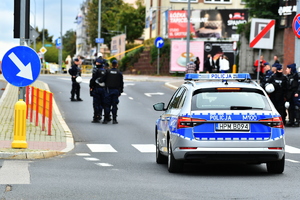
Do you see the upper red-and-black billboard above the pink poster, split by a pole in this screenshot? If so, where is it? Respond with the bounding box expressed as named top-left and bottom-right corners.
top-left (168, 9), bottom-right (248, 38)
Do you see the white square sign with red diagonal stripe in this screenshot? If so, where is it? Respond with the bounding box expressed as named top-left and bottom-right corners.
top-left (250, 18), bottom-right (275, 49)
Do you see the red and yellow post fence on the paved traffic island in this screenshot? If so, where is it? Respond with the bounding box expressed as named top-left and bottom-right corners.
top-left (26, 86), bottom-right (53, 135)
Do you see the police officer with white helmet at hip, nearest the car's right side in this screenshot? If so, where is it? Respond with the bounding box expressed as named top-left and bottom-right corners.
top-left (268, 64), bottom-right (287, 124)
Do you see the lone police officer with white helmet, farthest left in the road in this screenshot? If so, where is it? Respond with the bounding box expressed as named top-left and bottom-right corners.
top-left (69, 58), bottom-right (82, 101)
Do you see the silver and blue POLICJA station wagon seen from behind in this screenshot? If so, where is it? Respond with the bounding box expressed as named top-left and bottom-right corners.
top-left (153, 73), bottom-right (285, 173)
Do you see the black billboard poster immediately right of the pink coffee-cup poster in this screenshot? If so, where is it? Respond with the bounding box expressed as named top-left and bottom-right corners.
top-left (204, 42), bottom-right (234, 71)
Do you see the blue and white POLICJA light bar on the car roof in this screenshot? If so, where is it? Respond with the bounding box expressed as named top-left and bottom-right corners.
top-left (184, 73), bottom-right (251, 81)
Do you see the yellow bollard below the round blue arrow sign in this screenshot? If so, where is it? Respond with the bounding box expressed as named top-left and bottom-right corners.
top-left (11, 99), bottom-right (27, 149)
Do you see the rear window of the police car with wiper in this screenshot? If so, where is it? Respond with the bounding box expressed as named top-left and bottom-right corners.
top-left (191, 90), bottom-right (271, 110)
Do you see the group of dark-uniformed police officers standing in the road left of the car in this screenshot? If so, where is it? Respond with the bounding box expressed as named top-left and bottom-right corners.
top-left (69, 55), bottom-right (124, 124)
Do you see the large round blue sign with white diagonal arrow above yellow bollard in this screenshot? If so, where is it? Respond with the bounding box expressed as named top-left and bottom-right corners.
top-left (2, 46), bottom-right (41, 87)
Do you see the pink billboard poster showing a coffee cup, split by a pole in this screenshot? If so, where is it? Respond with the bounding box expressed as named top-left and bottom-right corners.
top-left (170, 40), bottom-right (204, 72)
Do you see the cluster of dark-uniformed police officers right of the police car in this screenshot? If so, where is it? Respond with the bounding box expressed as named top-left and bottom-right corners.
top-left (260, 62), bottom-right (300, 127)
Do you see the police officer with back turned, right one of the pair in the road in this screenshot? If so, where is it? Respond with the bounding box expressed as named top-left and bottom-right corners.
top-left (103, 60), bottom-right (124, 124)
